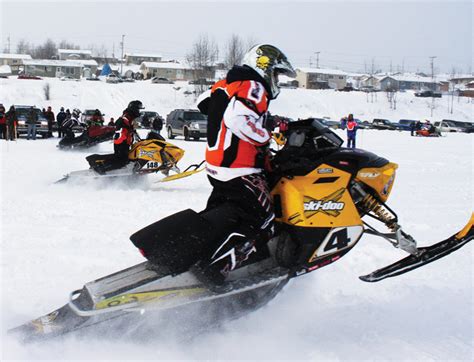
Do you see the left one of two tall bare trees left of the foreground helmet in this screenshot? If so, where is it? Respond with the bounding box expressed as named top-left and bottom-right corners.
top-left (186, 34), bottom-right (219, 94)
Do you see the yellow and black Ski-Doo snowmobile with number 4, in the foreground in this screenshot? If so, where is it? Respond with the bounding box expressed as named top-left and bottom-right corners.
top-left (10, 119), bottom-right (474, 341)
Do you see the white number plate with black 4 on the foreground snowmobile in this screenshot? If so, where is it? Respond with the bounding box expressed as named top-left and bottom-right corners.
top-left (311, 225), bottom-right (363, 261)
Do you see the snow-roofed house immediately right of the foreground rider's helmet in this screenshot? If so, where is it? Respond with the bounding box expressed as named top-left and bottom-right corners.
top-left (296, 68), bottom-right (347, 89)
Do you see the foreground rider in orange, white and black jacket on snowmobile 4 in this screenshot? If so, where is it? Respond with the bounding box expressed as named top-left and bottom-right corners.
top-left (193, 44), bottom-right (296, 284)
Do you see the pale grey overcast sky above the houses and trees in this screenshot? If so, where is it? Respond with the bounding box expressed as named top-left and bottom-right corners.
top-left (0, 0), bottom-right (473, 72)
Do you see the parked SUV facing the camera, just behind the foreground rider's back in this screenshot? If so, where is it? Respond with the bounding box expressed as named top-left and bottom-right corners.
top-left (166, 109), bottom-right (207, 141)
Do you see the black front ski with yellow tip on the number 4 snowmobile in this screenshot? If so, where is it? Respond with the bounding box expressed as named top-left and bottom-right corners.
top-left (359, 213), bottom-right (474, 282)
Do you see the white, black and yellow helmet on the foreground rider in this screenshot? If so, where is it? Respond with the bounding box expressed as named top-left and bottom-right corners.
top-left (242, 44), bottom-right (296, 99)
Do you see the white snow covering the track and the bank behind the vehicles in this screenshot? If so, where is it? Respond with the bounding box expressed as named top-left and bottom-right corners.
top-left (0, 78), bottom-right (474, 360)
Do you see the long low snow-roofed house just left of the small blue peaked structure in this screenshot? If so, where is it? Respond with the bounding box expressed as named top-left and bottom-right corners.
top-left (23, 59), bottom-right (83, 79)
